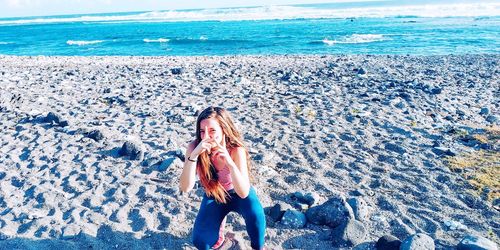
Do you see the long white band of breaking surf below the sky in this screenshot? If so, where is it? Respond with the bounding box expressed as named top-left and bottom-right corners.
top-left (0, 2), bottom-right (500, 25)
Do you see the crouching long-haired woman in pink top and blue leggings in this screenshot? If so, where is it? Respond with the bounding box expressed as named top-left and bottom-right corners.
top-left (180, 107), bottom-right (266, 249)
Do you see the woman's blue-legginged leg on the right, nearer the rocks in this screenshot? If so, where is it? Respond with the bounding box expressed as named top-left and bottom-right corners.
top-left (231, 187), bottom-right (266, 249)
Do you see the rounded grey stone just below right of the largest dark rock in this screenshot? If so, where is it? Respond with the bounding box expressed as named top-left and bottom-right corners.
top-left (332, 219), bottom-right (366, 247)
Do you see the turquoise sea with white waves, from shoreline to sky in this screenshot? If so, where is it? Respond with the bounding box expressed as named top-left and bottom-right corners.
top-left (0, 1), bottom-right (500, 56)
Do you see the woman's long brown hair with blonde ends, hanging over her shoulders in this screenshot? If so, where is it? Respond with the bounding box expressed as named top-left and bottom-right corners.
top-left (196, 107), bottom-right (250, 203)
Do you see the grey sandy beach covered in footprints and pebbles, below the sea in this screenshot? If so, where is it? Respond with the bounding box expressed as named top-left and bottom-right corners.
top-left (0, 54), bottom-right (500, 249)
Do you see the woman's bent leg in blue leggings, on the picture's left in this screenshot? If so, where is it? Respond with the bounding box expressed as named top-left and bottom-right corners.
top-left (193, 195), bottom-right (229, 249)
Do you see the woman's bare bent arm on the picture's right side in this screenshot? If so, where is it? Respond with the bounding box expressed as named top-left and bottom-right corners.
top-left (227, 147), bottom-right (250, 199)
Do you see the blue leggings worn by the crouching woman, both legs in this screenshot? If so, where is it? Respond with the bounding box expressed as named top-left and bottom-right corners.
top-left (193, 187), bottom-right (266, 249)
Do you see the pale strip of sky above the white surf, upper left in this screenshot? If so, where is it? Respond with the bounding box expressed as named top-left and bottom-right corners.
top-left (0, 0), bottom-right (390, 18)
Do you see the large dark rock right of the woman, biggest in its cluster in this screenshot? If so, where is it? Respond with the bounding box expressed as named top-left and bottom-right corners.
top-left (306, 195), bottom-right (354, 227)
